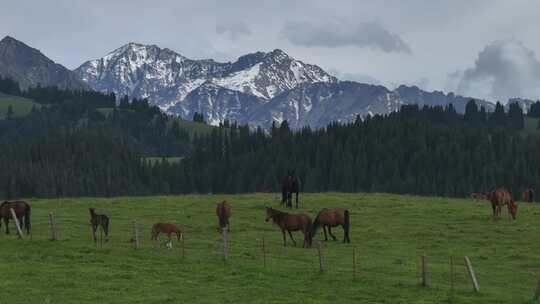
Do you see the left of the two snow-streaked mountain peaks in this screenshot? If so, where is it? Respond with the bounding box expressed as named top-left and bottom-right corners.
top-left (75, 43), bottom-right (231, 110)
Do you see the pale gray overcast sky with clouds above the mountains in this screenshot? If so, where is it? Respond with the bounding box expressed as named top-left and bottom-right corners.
top-left (0, 0), bottom-right (540, 101)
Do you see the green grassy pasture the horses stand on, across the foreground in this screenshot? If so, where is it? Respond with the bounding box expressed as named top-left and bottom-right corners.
top-left (0, 193), bottom-right (540, 304)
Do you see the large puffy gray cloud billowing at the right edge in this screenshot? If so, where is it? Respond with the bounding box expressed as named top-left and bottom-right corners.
top-left (450, 39), bottom-right (540, 102)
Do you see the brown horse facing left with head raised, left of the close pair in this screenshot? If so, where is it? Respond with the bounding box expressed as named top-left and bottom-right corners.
top-left (266, 207), bottom-right (311, 247)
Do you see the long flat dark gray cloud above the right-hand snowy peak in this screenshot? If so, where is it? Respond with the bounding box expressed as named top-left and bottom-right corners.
top-left (281, 21), bottom-right (411, 53)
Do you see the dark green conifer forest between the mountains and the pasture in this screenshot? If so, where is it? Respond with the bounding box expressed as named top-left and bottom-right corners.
top-left (0, 79), bottom-right (540, 198)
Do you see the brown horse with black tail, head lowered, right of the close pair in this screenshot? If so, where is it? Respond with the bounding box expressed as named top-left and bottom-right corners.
top-left (311, 208), bottom-right (351, 243)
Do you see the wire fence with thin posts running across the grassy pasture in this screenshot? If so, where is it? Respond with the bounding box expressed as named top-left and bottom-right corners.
top-left (4, 210), bottom-right (540, 296)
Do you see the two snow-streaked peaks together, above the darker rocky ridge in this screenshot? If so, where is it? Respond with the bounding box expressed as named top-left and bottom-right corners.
top-left (75, 43), bottom-right (336, 111)
